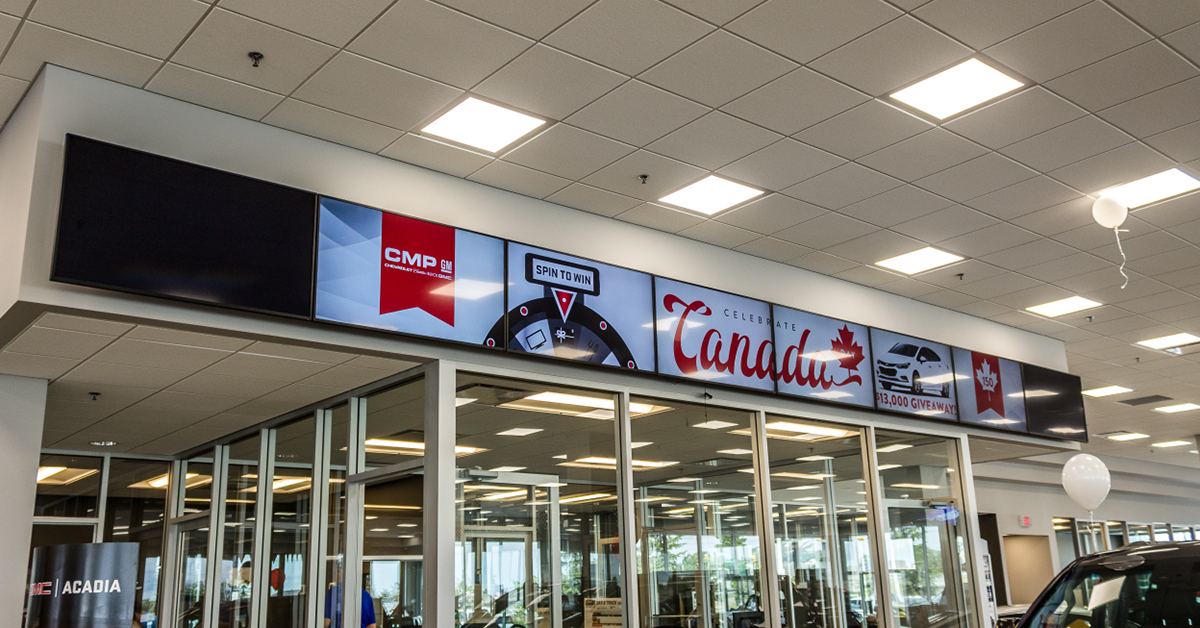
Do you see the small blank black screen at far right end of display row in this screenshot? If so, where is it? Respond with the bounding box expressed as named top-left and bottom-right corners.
top-left (1021, 364), bottom-right (1087, 443)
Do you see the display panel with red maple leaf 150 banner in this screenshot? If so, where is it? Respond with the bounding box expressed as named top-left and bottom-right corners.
top-left (954, 347), bottom-right (1025, 432)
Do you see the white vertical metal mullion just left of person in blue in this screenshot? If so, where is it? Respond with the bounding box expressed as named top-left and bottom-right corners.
top-left (304, 409), bottom-right (332, 626)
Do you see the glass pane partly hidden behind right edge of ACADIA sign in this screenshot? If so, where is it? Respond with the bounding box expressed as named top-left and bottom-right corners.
top-left (104, 459), bottom-right (170, 626)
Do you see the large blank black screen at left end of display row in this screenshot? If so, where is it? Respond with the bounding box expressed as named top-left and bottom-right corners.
top-left (50, 136), bottom-right (317, 318)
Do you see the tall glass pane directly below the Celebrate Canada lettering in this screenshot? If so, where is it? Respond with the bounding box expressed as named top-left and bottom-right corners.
top-left (630, 397), bottom-right (766, 628)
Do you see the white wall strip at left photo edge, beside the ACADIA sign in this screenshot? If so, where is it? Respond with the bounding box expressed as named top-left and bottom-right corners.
top-left (0, 375), bottom-right (47, 626)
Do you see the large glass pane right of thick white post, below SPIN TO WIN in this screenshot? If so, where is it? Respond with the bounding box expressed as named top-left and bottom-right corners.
top-left (455, 373), bottom-right (622, 628)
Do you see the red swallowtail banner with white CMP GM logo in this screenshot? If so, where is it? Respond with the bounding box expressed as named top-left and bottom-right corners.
top-left (379, 214), bottom-right (455, 327)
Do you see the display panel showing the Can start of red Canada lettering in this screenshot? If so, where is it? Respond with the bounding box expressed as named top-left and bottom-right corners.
top-left (654, 277), bottom-right (775, 390)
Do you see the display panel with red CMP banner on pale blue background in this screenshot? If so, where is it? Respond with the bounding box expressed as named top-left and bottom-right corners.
top-left (316, 197), bottom-right (504, 347)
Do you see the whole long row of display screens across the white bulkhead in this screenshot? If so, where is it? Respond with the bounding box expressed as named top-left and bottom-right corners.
top-left (52, 136), bottom-right (1087, 442)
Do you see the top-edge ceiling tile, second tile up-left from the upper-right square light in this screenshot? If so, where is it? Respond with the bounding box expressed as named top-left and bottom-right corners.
top-left (726, 0), bottom-right (900, 64)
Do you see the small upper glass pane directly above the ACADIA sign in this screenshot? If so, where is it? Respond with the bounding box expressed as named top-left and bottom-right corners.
top-left (34, 454), bottom-right (104, 516)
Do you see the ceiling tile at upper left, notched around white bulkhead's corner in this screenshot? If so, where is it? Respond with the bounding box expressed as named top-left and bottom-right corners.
top-left (0, 22), bottom-right (161, 88)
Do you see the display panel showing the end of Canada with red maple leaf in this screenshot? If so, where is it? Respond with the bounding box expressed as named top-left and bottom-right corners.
top-left (774, 305), bottom-right (875, 407)
